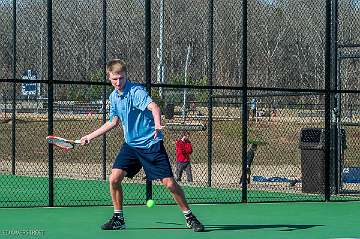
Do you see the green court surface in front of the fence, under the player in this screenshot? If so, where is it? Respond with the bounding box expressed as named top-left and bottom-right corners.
top-left (0, 202), bottom-right (360, 239)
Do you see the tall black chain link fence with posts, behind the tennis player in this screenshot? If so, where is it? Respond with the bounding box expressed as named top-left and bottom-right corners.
top-left (0, 0), bottom-right (360, 207)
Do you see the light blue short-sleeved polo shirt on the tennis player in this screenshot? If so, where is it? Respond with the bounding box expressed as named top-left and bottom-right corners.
top-left (109, 80), bottom-right (164, 148)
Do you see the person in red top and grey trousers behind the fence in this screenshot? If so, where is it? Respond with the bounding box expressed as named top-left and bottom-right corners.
top-left (175, 131), bottom-right (193, 182)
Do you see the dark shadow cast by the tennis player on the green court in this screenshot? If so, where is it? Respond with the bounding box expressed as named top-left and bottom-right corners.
top-left (132, 222), bottom-right (324, 232)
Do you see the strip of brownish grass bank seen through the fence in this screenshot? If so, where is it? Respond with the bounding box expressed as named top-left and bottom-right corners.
top-left (0, 116), bottom-right (360, 166)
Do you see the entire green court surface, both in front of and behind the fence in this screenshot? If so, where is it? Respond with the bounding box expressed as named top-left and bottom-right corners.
top-left (0, 175), bottom-right (360, 239)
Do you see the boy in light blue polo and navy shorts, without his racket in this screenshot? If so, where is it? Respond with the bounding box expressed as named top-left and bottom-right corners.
top-left (81, 59), bottom-right (204, 232)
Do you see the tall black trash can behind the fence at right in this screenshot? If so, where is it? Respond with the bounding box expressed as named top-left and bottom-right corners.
top-left (299, 128), bottom-right (346, 193)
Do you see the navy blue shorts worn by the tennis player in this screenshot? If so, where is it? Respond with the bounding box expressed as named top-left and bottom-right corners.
top-left (113, 140), bottom-right (173, 180)
